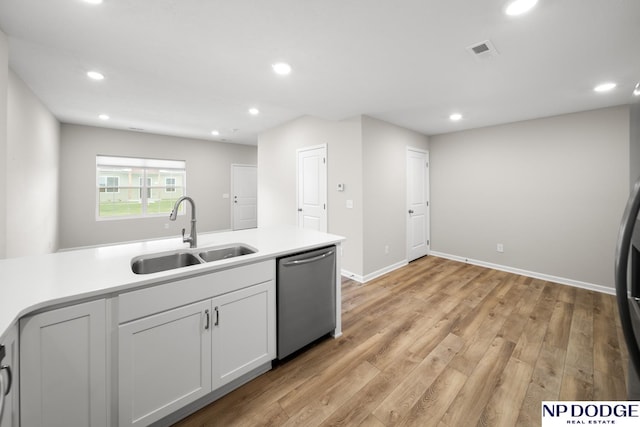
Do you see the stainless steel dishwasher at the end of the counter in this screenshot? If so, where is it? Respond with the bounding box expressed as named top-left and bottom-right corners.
top-left (276, 246), bottom-right (336, 359)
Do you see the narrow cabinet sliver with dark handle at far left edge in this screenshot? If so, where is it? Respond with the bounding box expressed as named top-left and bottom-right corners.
top-left (0, 327), bottom-right (20, 427)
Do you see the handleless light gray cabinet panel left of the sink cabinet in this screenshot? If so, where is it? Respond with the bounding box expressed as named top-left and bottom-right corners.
top-left (20, 300), bottom-right (107, 427)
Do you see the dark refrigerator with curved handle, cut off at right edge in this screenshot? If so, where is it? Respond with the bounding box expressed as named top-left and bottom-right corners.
top-left (615, 180), bottom-right (640, 400)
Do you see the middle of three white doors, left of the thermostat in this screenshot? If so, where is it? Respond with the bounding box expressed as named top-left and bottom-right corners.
top-left (297, 145), bottom-right (327, 232)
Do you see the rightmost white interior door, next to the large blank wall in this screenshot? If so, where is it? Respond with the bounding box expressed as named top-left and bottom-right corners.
top-left (407, 148), bottom-right (430, 261)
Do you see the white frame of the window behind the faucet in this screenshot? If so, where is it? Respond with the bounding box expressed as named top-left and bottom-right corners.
top-left (95, 155), bottom-right (187, 221)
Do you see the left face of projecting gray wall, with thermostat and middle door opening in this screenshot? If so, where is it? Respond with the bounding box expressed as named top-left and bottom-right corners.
top-left (258, 116), bottom-right (363, 274)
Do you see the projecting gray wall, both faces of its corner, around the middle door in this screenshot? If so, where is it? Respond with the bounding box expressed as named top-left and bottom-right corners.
top-left (258, 116), bottom-right (428, 280)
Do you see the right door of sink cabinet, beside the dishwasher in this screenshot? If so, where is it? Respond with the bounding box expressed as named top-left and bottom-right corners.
top-left (212, 280), bottom-right (276, 389)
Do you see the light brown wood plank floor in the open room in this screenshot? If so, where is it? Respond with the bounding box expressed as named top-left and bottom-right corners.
top-left (177, 257), bottom-right (627, 427)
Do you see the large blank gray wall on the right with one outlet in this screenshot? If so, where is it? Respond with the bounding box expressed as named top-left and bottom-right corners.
top-left (430, 106), bottom-right (630, 288)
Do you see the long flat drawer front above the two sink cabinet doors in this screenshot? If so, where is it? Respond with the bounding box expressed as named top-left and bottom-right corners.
top-left (118, 260), bottom-right (276, 324)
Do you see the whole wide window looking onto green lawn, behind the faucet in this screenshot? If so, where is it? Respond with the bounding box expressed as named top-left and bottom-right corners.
top-left (96, 156), bottom-right (187, 219)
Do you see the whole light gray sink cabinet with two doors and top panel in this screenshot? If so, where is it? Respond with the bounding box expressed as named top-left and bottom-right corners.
top-left (118, 260), bottom-right (276, 427)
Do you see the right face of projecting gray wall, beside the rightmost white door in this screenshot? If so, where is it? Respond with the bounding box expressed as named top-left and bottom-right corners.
top-left (362, 116), bottom-right (429, 278)
